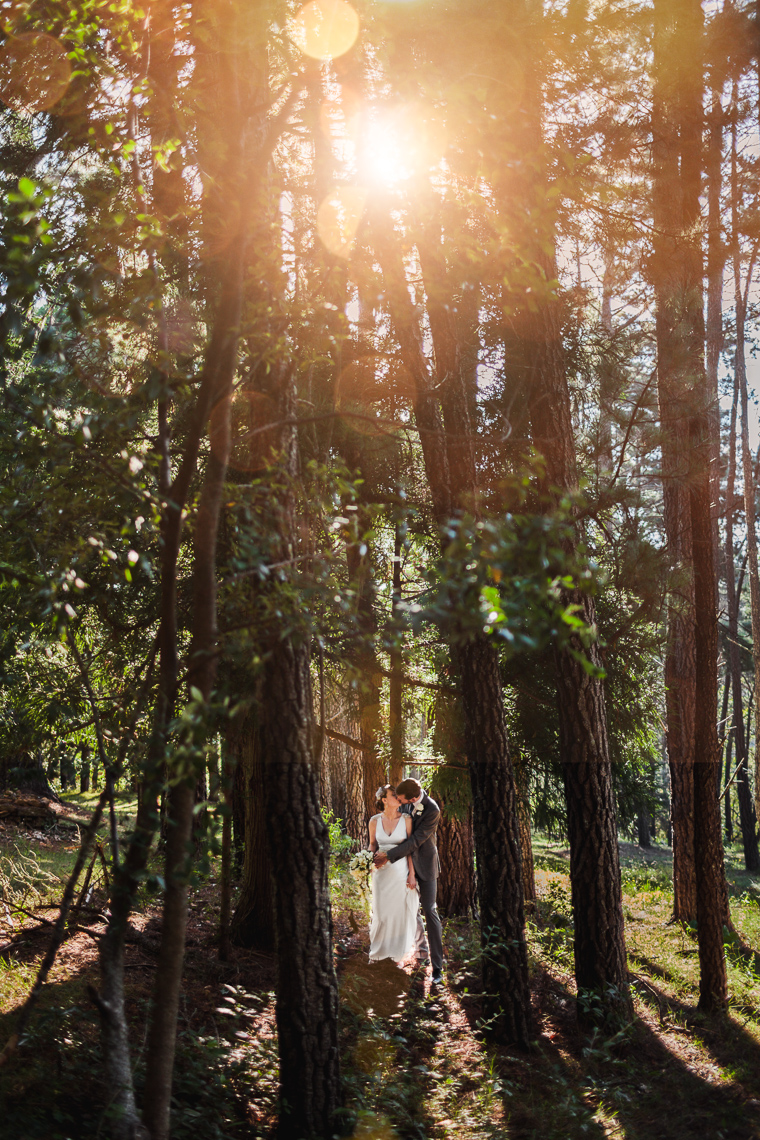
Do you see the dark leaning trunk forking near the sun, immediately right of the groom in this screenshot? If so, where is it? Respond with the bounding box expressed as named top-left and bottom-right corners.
top-left (374, 209), bottom-right (531, 1044)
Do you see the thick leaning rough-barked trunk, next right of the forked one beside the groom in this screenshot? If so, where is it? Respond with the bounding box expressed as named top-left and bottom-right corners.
top-left (487, 0), bottom-right (632, 1023)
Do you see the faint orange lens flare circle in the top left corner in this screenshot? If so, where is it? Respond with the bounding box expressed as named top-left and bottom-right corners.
top-left (0, 32), bottom-right (72, 114)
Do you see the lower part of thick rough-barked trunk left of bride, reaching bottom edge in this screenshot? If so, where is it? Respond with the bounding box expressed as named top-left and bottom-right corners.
top-left (262, 641), bottom-right (340, 1140)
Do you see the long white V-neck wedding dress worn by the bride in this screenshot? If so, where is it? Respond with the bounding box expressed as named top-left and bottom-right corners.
top-left (369, 815), bottom-right (419, 962)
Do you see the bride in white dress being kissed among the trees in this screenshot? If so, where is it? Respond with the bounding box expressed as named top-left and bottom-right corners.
top-left (369, 784), bottom-right (419, 962)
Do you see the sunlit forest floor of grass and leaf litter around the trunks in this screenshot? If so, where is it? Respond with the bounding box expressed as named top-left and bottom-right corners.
top-left (0, 797), bottom-right (760, 1140)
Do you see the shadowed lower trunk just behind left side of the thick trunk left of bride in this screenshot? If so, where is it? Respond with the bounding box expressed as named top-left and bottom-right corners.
top-left (230, 706), bottom-right (275, 953)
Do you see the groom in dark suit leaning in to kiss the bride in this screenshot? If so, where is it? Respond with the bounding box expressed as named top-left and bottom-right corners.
top-left (375, 779), bottom-right (443, 983)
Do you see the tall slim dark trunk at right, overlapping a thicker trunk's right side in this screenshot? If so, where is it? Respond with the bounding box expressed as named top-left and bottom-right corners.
top-left (655, 0), bottom-right (728, 1009)
